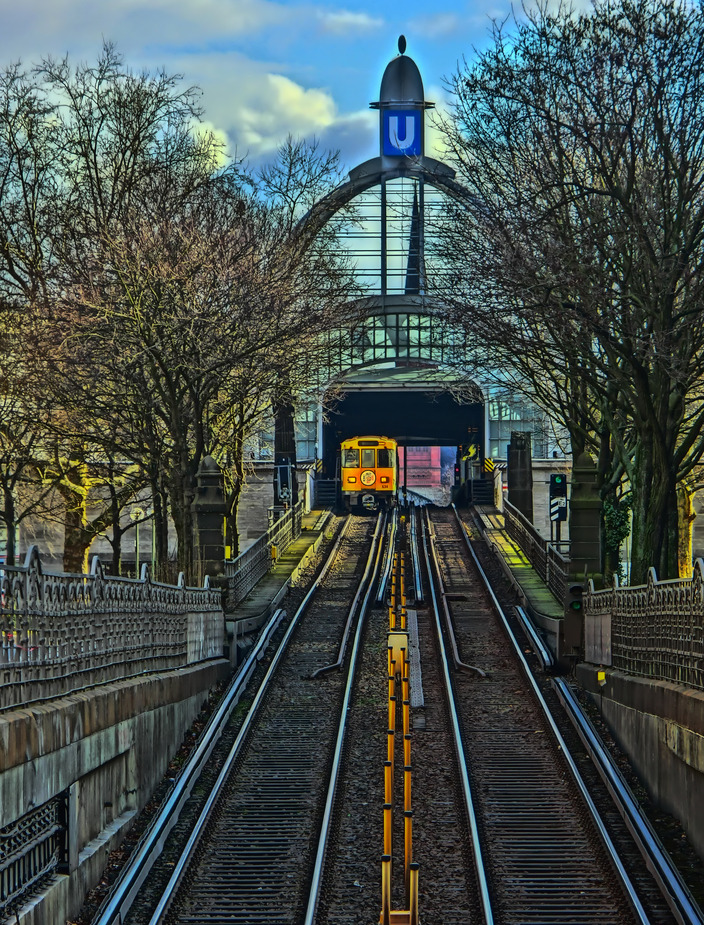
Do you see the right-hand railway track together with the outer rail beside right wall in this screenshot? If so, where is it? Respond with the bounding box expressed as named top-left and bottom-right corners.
top-left (430, 510), bottom-right (701, 925)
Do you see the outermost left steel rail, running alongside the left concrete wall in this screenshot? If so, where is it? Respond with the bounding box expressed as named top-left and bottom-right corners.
top-left (93, 609), bottom-right (285, 925)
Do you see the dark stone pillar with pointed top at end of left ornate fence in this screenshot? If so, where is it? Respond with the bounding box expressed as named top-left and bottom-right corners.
top-left (191, 456), bottom-right (227, 578)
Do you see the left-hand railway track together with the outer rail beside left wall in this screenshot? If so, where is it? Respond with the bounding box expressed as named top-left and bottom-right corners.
top-left (96, 518), bottom-right (383, 925)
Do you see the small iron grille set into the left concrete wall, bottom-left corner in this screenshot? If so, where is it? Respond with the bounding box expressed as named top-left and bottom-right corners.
top-left (0, 791), bottom-right (68, 921)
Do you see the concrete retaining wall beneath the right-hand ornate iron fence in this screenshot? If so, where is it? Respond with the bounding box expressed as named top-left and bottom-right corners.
top-left (577, 664), bottom-right (704, 858)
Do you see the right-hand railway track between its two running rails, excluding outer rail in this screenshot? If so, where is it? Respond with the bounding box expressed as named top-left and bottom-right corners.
top-left (430, 511), bottom-right (646, 925)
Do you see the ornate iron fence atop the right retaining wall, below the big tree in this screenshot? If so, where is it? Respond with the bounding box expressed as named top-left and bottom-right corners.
top-left (584, 559), bottom-right (704, 689)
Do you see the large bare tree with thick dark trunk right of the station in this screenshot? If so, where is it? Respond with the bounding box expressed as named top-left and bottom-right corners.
top-left (438, 0), bottom-right (704, 580)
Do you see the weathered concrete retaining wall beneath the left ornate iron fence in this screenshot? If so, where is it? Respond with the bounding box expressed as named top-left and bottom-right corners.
top-left (0, 659), bottom-right (231, 925)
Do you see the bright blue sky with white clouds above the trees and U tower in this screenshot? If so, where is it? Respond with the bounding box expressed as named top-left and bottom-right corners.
top-left (0, 0), bottom-right (511, 168)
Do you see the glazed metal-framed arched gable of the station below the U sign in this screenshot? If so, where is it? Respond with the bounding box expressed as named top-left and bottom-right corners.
top-left (298, 155), bottom-right (482, 388)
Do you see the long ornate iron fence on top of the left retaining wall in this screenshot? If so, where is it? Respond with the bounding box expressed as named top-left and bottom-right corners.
top-left (0, 546), bottom-right (224, 710)
